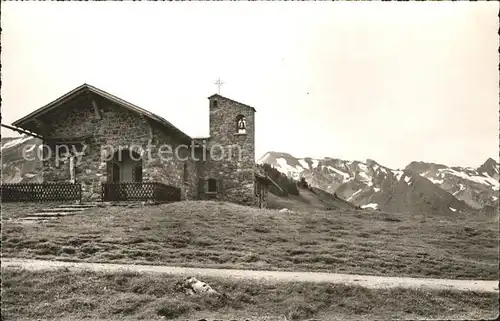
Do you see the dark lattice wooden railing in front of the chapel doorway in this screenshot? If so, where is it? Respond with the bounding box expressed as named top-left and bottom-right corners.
top-left (102, 182), bottom-right (181, 202)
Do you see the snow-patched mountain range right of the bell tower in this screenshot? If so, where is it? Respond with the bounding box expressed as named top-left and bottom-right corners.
top-left (257, 152), bottom-right (500, 214)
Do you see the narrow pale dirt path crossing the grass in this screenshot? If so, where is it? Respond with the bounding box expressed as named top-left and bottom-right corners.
top-left (2, 258), bottom-right (498, 293)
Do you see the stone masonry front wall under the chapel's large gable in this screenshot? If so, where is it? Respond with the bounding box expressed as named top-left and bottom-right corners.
top-left (39, 97), bottom-right (199, 201)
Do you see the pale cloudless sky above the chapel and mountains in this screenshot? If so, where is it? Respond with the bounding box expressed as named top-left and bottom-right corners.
top-left (1, 1), bottom-right (499, 168)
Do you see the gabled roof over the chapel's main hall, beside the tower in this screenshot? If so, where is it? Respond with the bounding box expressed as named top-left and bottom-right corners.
top-left (12, 84), bottom-right (191, 140)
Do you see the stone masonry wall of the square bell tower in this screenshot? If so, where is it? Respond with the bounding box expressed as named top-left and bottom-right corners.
top-left (202, 95), bottom-right (255, 205)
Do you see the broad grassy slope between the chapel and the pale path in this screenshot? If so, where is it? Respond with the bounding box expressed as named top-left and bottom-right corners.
top-left (2, 201), bottom-right (498, 280)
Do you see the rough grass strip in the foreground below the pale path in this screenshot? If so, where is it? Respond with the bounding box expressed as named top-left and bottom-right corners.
top-left (2, 269), bottom-right (498, 321)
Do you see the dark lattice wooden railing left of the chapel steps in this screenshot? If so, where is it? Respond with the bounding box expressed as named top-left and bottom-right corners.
top-left (1, 183), bottom-right (82, 202)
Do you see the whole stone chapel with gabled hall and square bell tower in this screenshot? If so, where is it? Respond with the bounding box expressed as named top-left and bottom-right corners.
top-left (12, 84), bottom-right (272, 207)
